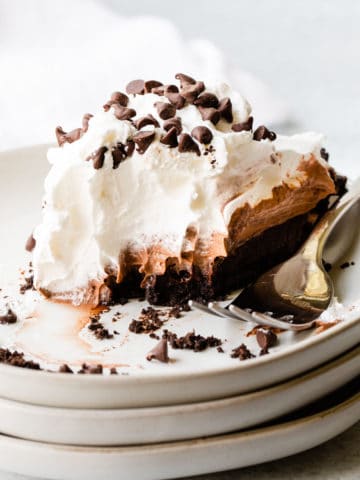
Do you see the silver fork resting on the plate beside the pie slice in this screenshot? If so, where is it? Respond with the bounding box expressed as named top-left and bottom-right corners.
top-left (189, 179), bottom-right (360, 332)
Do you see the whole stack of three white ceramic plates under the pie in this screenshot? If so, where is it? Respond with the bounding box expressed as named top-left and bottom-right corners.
top-left (0, 147), bottom-right (360, 480)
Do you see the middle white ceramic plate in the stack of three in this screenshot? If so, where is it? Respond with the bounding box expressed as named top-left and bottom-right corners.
top-left (0, 347), bottom-right (360, 446)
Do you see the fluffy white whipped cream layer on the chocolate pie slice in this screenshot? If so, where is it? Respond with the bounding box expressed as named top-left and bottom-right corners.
top-left (33, 78), bottom-right (334, 303)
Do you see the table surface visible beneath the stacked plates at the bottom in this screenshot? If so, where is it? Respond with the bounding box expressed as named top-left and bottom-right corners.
top-left (0, 423), bottom-right (360, 480)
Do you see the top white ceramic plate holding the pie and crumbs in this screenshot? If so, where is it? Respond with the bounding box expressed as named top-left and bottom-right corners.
top-left (0, 146), bottom-right (360, 408)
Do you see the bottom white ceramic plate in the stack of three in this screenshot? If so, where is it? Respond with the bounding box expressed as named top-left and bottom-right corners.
top-left (0, 384), bottom-right (360, 480)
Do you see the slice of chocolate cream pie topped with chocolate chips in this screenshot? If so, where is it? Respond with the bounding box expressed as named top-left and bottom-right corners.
top-left (28, 74), bottom-right (344, 305)
